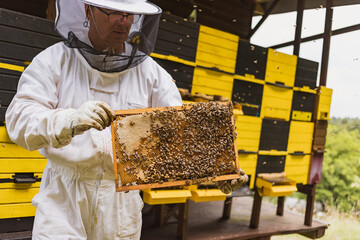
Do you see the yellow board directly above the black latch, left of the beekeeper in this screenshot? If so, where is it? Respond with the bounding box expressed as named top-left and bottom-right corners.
top-left (0, 158), bottom-right (47, 173)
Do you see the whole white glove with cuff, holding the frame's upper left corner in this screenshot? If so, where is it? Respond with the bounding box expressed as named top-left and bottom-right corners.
top-left (51, 101), bottom-right (115, 147)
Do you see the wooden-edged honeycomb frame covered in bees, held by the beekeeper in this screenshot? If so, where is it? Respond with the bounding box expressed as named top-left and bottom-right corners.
top-left (111, 102), bottom-right (240, 191)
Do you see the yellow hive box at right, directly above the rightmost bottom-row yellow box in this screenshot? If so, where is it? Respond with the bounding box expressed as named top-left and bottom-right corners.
top-left (287, 121), bottom-right (314, 154)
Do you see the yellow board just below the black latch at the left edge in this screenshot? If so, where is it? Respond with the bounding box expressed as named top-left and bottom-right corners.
top-left (0, 188), bottom-right (39, 204)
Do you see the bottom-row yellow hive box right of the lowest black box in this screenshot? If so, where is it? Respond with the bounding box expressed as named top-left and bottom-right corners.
top-left (285, 155), bottom-right (311, 184)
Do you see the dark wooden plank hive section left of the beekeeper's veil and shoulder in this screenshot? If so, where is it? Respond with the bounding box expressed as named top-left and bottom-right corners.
top-left (0, 9), bottom-right (61, 125)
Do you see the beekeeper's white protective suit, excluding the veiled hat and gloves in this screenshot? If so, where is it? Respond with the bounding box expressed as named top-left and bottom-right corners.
top-left (6, 43), bottom-right (182, 240)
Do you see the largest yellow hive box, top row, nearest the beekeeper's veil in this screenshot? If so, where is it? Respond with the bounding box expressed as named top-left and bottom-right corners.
top-left (195, 25), bottom-right (239, 73)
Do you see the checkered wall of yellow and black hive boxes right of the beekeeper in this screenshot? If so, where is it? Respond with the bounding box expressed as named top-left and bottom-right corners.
top-left (149, 14), bottom-right (332, 197)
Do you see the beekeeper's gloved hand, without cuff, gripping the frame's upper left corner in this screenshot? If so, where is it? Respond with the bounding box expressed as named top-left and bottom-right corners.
top-left (70, 101), bottom-right (115, 136)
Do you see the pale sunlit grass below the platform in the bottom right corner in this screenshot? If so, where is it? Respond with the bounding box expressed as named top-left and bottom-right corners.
top-left (271, 210), bottom-right (360, 240)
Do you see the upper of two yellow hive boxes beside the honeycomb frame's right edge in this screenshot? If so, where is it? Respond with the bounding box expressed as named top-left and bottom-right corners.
top-left (235, 114), bottom-right (262, 152)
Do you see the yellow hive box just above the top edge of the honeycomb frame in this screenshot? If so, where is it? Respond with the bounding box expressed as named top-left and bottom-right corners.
top-left (191, 67), bottom-right (234, 99)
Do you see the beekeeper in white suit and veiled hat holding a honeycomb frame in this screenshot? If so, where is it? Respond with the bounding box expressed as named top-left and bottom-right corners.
top-left (6, 0), bottom-right (246, 237)
